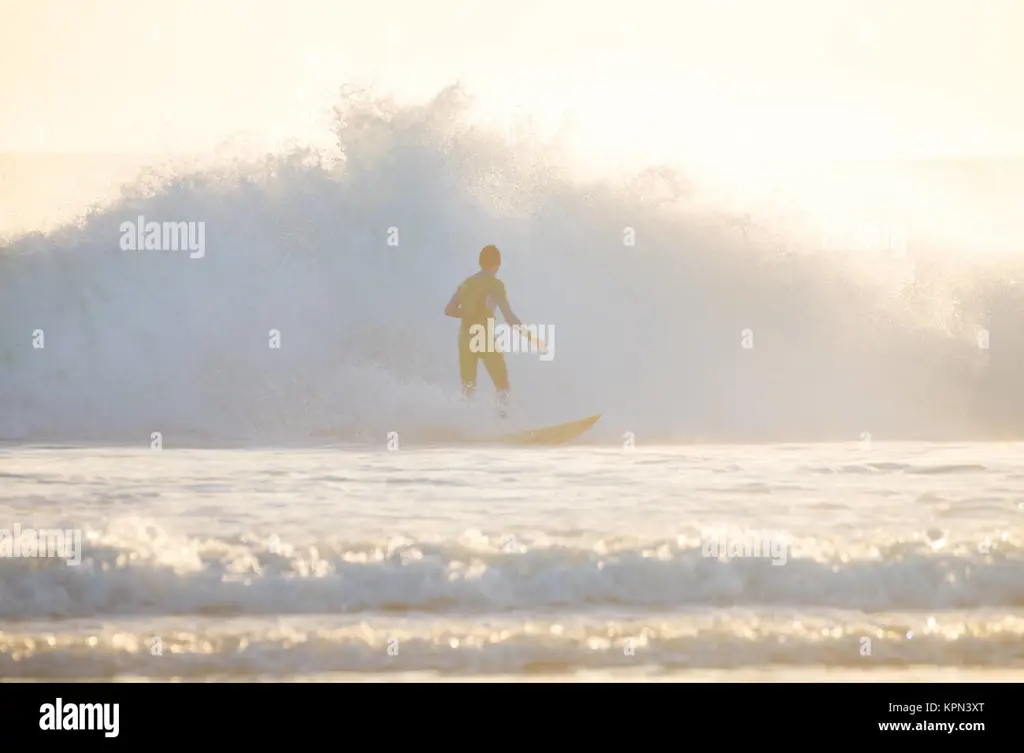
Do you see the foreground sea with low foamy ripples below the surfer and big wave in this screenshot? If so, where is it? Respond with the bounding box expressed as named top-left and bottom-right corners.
top-left (0, 441), bottom-right (1024, 681)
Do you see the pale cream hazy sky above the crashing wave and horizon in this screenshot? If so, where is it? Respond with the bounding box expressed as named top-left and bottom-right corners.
top-left (0, 0), bottom-right (1024, 161)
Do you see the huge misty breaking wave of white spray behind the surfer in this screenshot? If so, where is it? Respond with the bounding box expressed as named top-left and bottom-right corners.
top-left (0, 88), bottom-right (1024, 446)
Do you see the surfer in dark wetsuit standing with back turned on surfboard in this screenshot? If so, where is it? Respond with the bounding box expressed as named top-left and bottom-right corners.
top-left (444, 246), bottom-right (522, 418)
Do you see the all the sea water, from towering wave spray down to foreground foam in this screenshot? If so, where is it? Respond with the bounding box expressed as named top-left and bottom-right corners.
top-left (0, 87), bottom-right (1024, 680)
